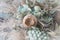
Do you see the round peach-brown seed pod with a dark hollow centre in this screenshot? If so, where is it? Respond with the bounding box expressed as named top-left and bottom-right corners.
top-left (23, 14), bottom-right (37, 28)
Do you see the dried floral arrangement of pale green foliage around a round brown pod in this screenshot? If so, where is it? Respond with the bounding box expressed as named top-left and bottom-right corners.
top-left (16, 0), bottom-right (57, 40)
